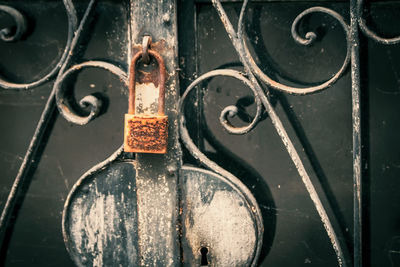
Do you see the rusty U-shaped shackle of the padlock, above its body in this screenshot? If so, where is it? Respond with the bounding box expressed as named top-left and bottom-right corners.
top-left (128, 49), bottom-right (165, 115)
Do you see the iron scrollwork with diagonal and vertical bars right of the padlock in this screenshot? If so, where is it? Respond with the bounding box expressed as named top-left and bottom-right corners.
top-left (180, 0), bottom-right (400, 266)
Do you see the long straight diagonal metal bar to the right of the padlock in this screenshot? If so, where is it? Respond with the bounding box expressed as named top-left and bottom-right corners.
top-left (212, 0), bottom-right (347, 266)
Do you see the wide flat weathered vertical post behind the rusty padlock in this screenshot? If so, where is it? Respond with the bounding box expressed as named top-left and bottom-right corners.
top-left (128, 0), bottom-right (181, 266)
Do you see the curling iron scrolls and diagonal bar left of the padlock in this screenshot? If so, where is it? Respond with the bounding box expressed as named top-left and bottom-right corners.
top-left (0, 0), bottom-right (127, 249)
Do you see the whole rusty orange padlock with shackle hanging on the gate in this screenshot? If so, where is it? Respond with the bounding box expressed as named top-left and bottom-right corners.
top-left (124, 49), bottom-right (168, 154)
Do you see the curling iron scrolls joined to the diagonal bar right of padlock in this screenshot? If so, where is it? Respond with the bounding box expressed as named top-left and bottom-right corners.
top-left (179, 0), bottom-right (351, 266)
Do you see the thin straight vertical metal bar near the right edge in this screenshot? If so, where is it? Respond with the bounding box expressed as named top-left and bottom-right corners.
top-left (350, 0), bottom-right (362, 267)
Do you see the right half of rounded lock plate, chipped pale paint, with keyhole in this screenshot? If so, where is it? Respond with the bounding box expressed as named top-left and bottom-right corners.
top-left (180, 166), bottom-right (261, 266)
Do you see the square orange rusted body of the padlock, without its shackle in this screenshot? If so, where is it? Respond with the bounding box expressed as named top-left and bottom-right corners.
top-left (124, 114), bottom-right (168, 154)
